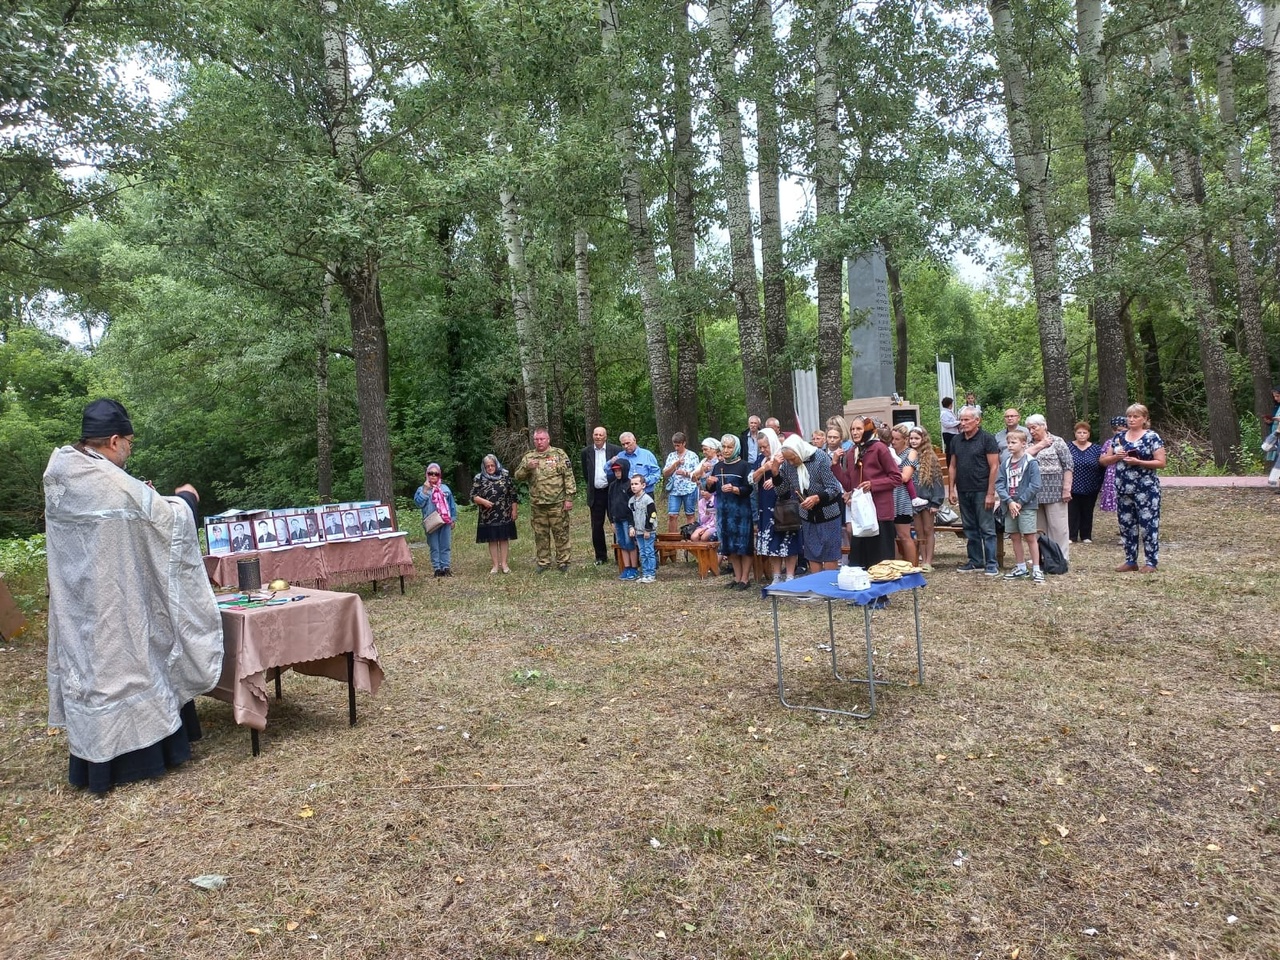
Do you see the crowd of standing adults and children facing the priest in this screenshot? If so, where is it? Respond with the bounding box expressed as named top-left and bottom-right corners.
top-left (415, 393), bottom-right (1177, 590)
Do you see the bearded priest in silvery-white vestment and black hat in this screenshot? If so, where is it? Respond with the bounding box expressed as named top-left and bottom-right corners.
top-left (45, 399), bottom-right (223, 792)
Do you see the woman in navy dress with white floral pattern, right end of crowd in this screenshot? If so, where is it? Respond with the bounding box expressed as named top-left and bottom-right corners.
top-left (1098, 403), bottom-right (1166, 573)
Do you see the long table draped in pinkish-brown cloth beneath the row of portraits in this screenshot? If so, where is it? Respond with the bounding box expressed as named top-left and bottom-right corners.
top-left (205, 534), bottom-right (415, 593)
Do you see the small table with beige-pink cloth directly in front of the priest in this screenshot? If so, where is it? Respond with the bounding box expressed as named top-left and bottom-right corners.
top-left (209, 588), bottom-right (383, 756)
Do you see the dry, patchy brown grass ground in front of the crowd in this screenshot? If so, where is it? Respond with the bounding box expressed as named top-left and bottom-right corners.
top-left (0, 490), bottom-right (1280, 960)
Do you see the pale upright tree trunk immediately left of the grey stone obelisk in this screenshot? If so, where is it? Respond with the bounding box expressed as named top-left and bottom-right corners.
top-left (813, 0), bottom-right (845, 417)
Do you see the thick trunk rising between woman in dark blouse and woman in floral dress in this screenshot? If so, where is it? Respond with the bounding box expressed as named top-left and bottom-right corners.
top-left (1075, 0), bottom-right (1129, 420)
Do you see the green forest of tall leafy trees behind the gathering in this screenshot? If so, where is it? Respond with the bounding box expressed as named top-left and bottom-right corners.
top-left (0, 0), bottom-right (1280, 536)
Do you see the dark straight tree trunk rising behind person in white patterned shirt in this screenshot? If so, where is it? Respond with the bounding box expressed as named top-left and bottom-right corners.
top-left (671, 0), bottom-right (704, 442)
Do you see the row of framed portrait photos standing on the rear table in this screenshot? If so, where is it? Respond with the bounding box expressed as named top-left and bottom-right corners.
top-left (205, 503), bottom-right (394, 557)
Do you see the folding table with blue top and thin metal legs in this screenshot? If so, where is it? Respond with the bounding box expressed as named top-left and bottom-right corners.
top-left (763, 570), bottom-right (925, 719)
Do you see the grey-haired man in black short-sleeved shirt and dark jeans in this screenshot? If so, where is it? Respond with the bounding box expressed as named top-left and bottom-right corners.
top-left (947, 404), bottom-right (1000, 577)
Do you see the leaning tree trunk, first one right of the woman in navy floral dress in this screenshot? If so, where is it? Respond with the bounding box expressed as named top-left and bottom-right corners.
top-left (1167, 24), bottom-right (1240, 466)
